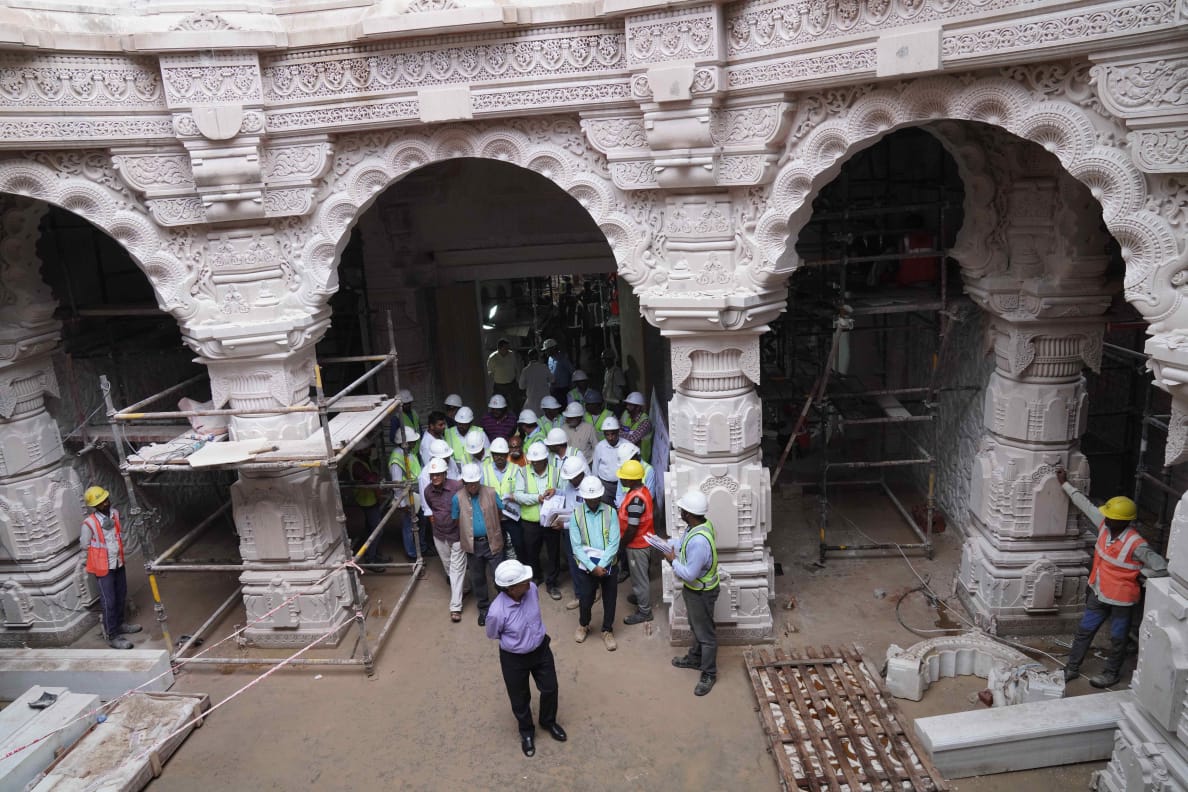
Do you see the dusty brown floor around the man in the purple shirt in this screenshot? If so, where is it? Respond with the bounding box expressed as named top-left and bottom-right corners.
top-left (55, 488), bottom-right (1111, 792)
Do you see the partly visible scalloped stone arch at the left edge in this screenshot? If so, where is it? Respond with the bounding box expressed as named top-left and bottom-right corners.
top-left (0, 151), bottom-right (198, 322)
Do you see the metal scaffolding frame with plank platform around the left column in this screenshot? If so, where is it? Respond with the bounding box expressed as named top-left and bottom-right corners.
top-left (100, 313), bottom-right (424, 676)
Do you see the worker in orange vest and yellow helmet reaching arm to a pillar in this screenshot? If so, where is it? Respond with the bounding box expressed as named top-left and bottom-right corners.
top-left (1056, 469), bottom-right (1168, 688)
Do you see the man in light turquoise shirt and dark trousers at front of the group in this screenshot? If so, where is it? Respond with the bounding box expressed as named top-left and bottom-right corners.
top-left (569, 476), bottom-right (620, 652)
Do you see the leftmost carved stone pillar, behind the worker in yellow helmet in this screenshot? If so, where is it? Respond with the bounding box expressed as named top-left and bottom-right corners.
top-left (0, 197), bottom-right (95, 646)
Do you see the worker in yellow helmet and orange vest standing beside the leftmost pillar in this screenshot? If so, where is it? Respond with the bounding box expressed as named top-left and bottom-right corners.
top-left (78, 486), bottom-right (141, 650)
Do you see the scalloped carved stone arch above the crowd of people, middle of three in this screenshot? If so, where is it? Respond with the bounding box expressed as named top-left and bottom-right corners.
top-left (293, 118), bottom-right (662, 309)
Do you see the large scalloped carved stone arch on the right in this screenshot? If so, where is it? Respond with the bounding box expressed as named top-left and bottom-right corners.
top-left (756, 76), bottom-right (1188, 331)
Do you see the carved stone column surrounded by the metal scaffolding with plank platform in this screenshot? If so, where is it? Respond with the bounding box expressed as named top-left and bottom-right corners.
top-left (184, 229), bottom-right (352, 646)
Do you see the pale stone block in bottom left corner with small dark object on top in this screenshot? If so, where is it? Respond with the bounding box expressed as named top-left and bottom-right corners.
top-left (0, 685), bottom-right (100, 792)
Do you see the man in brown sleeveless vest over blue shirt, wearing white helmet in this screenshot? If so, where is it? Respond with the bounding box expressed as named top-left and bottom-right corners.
top-left (450, 462), bottom-right (504, 627)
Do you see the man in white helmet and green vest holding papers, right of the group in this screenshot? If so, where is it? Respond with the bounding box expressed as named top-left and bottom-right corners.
top-left (664, 489), bottom-right (718, 696)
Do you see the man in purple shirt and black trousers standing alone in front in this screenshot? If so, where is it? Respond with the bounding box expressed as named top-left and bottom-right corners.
top-left (486, 560), bottom-right (569, 756)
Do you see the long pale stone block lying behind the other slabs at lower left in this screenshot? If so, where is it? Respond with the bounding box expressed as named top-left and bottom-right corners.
top-left (0, 650), bottom-right (173, 701)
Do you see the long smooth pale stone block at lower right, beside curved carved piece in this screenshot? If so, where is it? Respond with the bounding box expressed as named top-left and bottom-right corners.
top-left (916, 690), bottom-right (1135, 778)
